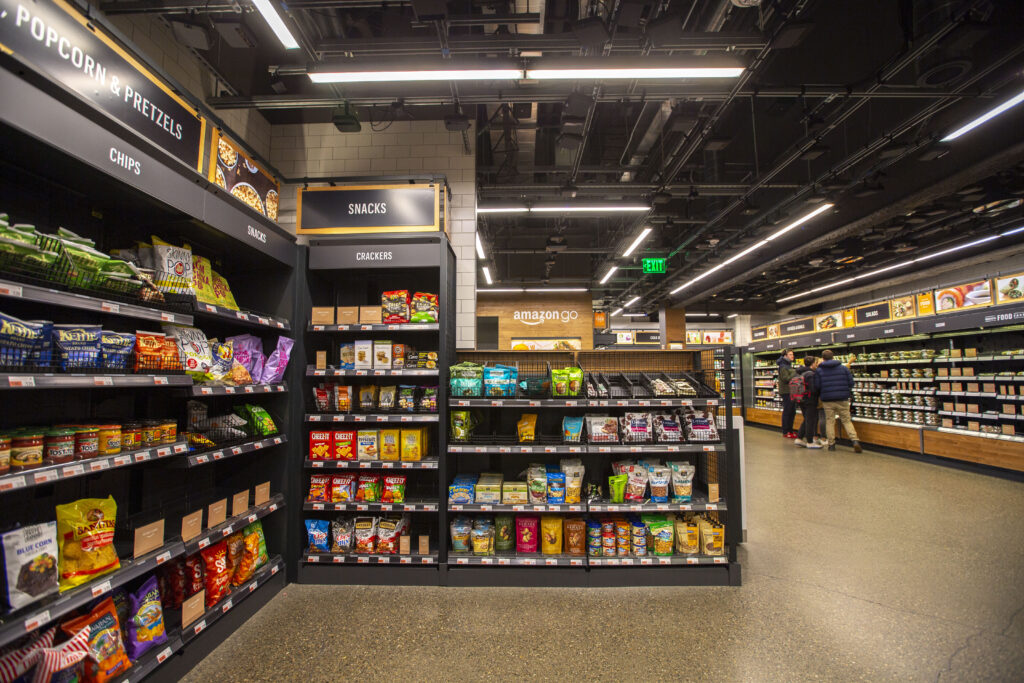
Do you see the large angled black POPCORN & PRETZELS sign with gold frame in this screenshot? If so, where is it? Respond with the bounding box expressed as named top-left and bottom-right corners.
top-left (0, 0), bottom-right (206, 172)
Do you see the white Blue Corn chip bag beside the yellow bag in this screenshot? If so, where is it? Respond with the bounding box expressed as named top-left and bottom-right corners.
top-left (0, 522), bottom-right (57, 609)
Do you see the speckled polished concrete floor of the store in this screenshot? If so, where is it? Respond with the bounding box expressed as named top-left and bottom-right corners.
top-left (185, 428), bottom-right (1024, 683)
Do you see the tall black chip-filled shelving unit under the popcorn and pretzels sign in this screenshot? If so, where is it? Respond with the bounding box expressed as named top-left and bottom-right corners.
top-left (0, 44), bottom-right (301, 681)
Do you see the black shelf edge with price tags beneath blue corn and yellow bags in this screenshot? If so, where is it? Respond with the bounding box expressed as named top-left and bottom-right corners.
top-left (0, 541), bottom-right (184, 647)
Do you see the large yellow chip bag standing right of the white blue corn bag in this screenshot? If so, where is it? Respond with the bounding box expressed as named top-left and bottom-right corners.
top-left (56, 496), bottom-right (121, 591)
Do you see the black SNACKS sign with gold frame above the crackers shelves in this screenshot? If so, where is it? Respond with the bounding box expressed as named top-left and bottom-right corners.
top-left (296, 183), bottom-right (440, 234)
